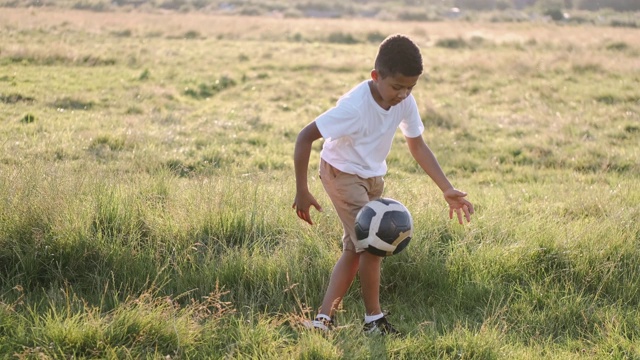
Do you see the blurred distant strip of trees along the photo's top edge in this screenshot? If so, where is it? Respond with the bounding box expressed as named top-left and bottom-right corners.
top-left (0, 0), bottom-right (640, 15)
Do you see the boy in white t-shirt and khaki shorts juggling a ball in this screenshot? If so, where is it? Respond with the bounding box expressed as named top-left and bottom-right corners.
top-left (293, 35), bottom-right (473, 334)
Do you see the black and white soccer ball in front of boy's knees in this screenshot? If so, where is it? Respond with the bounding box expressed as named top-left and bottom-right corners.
top-left (355, 198), bottom-right (413, 256)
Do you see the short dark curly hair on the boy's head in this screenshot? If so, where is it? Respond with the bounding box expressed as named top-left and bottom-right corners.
top-left (375, 34), bottom-right (423, 78)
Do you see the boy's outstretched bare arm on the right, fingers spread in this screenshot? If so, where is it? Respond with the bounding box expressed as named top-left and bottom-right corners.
top-left (406, 136), bottom-right (473, 224)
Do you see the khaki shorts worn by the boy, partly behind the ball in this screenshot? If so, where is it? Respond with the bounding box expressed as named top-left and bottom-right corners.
top-left (319, 160), bottom-right (384, 252)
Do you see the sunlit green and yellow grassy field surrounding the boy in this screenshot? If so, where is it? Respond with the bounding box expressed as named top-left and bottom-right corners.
top-left (0, 9), bottom-right (640, 359)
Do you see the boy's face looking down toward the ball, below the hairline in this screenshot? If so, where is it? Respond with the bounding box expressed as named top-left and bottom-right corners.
top-left (370, 70), bottom-right (420, 109)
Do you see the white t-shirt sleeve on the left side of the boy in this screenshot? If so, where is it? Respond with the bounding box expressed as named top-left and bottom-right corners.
top-left (315, 103), bottom-right (361, 140)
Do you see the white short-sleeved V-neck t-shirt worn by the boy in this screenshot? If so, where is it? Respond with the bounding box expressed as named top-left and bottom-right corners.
top-left (315, 80), bottom-right (424, 178)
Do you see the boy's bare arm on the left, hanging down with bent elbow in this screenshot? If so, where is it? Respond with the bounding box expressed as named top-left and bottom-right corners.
top-left (292, 121), bottom-right (322, 225)
